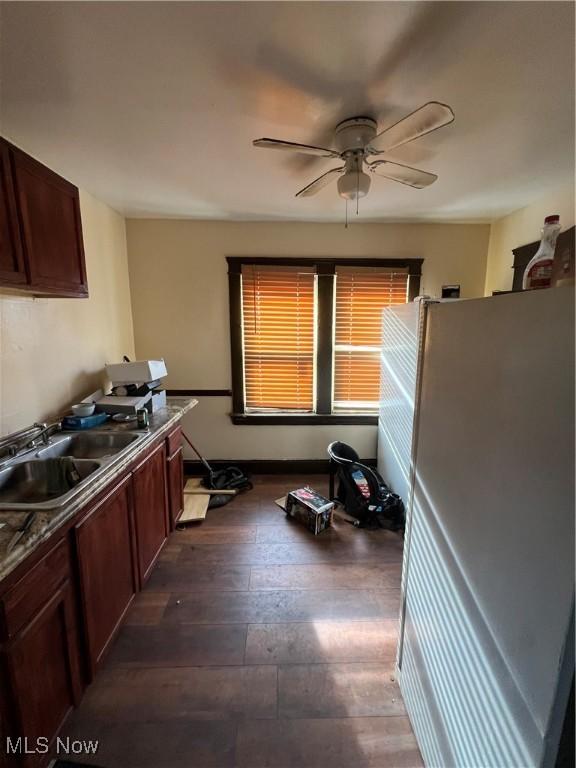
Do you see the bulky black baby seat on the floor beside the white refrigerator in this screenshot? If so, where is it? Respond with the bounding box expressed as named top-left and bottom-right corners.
top-left (328, 441), bottom-right (405, 532)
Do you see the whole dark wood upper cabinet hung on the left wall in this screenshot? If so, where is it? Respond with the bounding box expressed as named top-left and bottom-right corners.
top-left (0, 139), bottom-right (88, 297)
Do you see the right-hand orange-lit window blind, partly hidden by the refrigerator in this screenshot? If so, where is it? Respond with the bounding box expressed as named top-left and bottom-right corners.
top-left (333, 267), bottom-right (408, 411)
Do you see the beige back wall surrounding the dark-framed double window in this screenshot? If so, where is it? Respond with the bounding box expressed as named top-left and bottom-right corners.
top-left (127, 219), bottom-right (489, 459)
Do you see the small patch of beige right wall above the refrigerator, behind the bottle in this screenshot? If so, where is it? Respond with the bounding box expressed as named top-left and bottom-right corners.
top-left (485, 185), bottom-right (574, 296)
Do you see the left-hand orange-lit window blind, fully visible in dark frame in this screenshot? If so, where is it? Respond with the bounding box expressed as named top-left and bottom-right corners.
top-left (242, 265), bottom-right (315, 411)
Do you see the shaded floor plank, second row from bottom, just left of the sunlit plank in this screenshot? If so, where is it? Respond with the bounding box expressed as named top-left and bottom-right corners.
top-left (72, 666), bottom-right (277, 723)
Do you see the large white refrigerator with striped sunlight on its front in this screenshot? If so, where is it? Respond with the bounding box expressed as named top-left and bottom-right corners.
top-left (378, 288), bottom-right (574, 768)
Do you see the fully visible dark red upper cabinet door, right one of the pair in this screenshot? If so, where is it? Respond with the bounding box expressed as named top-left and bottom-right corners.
top-left (10, 142), bottom-right (88, 296)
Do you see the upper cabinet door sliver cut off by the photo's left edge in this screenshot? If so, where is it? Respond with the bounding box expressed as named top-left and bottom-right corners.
top-left (0, 139), bottom-right (27, 286)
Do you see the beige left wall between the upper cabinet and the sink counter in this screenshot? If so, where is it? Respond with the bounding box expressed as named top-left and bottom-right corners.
top-left (0, 192), bottom-right (134, 434)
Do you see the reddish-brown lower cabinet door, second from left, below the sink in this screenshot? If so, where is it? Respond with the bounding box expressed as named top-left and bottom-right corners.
top-left (75, 478), bottom-right (136, 675)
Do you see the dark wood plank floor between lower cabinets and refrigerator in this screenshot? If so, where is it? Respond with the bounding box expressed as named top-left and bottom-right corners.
top-left (60, 476), bottom-right (422, 768)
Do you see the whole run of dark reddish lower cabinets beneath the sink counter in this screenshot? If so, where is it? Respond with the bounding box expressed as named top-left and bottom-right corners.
top-left (0, 431), bottom-right (173, 768)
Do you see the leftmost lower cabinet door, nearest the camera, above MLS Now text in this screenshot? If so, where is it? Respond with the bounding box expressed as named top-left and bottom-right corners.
top-left (3, 581), bottom-right (81, 766)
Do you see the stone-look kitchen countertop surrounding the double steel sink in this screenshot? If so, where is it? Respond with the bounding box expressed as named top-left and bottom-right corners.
top-left (0, 397), bottom-right (198, 580)
